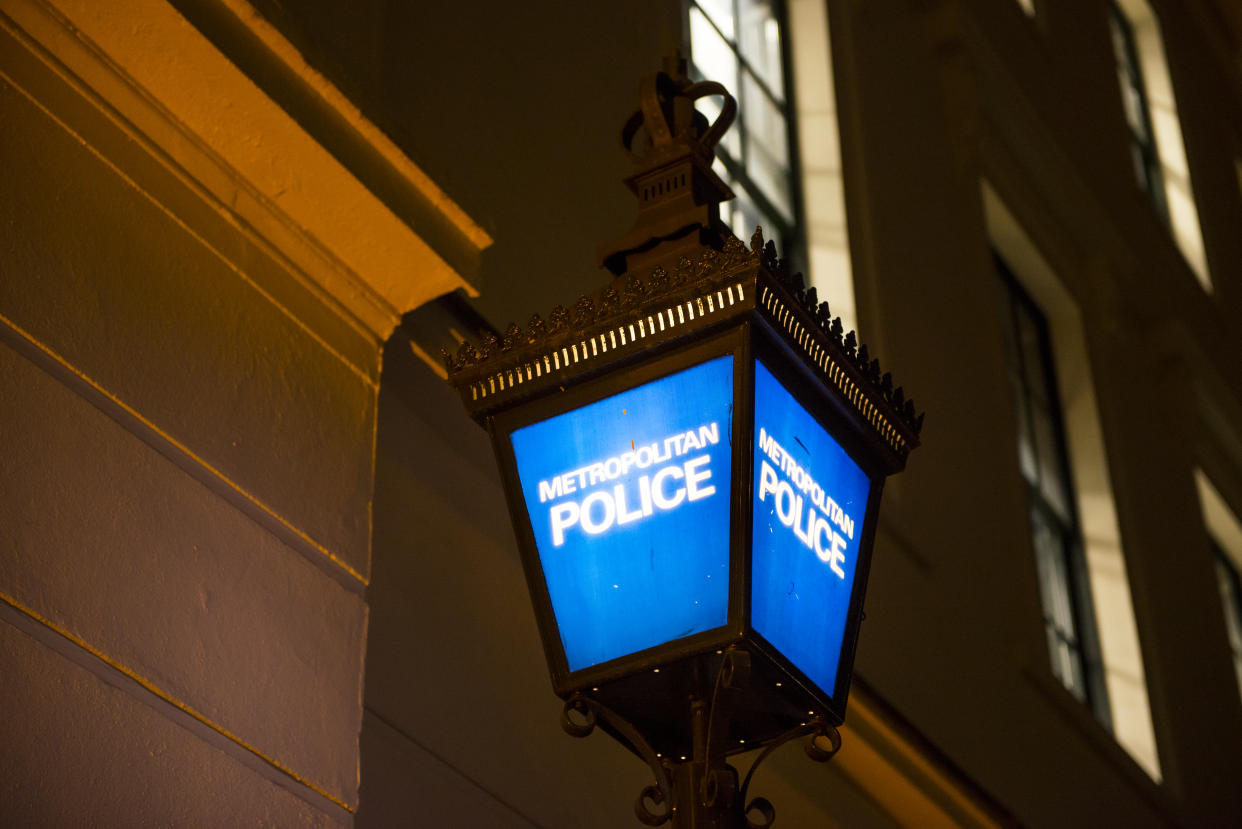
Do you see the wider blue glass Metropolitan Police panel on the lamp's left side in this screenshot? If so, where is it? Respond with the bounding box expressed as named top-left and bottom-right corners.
top-left (510, 355), bottom-right (733, 671)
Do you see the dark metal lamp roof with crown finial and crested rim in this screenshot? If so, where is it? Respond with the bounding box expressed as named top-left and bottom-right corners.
top-left (441, 53), bottom-right (923, 471)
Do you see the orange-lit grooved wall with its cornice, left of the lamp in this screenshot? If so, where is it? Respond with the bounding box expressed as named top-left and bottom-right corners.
top-left (0, 0), bottom-right (487, 827)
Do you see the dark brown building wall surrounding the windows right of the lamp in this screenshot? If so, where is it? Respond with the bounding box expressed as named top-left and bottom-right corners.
top-left (830, 0), bottom-right (1242, 825)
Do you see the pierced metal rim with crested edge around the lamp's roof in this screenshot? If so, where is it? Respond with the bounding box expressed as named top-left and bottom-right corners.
top-left (441, 229), bottom-right (923, 464)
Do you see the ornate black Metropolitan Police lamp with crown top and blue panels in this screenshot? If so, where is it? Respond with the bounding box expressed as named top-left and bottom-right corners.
top-left (445, 56), bottom-right (923, 829)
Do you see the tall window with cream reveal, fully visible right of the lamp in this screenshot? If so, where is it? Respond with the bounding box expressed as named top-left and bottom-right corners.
top-left (980, 180), bottom-right (1161, 781)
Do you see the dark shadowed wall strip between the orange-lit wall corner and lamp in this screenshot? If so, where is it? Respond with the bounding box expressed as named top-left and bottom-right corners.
top-left (358, 332), bottom-right (648, 829)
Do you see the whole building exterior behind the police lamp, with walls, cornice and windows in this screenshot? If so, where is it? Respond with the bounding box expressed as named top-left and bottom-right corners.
top-left (0, 0), bottom-right (1242, 828)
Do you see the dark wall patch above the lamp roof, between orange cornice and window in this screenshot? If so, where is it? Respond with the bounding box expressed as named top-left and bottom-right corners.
top-left (231, 0), bottom-right (681, 327)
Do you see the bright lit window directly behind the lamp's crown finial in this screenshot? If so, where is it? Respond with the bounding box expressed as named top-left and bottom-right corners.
top-left (689, 0), bottom-right (801, 260)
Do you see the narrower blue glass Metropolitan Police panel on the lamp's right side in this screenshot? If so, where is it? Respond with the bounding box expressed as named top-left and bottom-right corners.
top-left (750, 362), bottom-right (871, 696)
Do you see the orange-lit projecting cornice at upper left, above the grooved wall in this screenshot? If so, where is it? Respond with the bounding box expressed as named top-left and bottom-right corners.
top-left (0, 0), bottom-right (492, 343)
